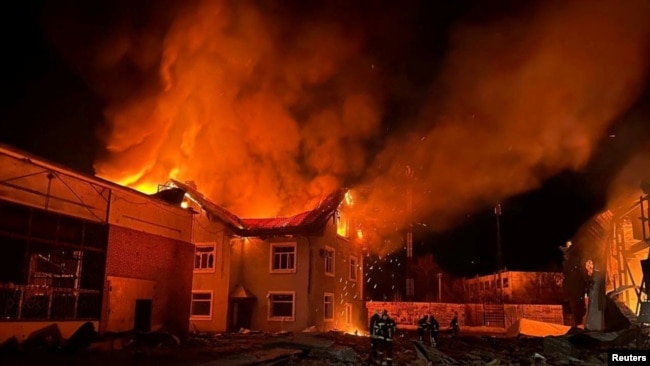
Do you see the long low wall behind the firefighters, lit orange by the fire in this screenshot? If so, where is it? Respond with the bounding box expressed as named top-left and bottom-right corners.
top-left (366, 301), bottom-right (564, 328)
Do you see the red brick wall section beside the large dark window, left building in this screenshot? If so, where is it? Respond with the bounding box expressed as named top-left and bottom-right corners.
top-left (103, 225), bottom-right (194, 334)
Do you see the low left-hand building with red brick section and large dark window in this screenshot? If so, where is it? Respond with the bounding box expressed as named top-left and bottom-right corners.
top-left (0, 146), bottom-right (194, 340)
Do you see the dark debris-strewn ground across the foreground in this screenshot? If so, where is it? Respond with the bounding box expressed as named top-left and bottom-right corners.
top-left (0, 330), bottom-right (636, 366)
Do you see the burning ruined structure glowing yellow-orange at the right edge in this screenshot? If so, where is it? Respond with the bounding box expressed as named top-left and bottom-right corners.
top-left (561, 192), bottom-right (650, 330)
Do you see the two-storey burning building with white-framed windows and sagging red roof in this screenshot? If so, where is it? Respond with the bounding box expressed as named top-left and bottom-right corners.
top-left (161, 181), bottom-right (365, 332)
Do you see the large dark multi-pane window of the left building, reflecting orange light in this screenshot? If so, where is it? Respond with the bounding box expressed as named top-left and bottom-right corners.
top-left (0, 200), bottom-right (108, 321)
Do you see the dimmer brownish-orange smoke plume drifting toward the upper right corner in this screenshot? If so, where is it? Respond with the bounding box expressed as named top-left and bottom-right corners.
top-left (352, 1), bottom-right (650, 254)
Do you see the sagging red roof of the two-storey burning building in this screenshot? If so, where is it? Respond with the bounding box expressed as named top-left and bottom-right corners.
top-left (167, 179), bottom-right (348, 237)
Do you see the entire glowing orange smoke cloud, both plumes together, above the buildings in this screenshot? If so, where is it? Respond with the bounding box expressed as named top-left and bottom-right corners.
top-left (44, 0), bottom-right (650, 254)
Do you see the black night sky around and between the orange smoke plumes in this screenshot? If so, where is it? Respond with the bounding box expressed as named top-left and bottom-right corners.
top-left (0, 0), bottom-right (650, 275)
